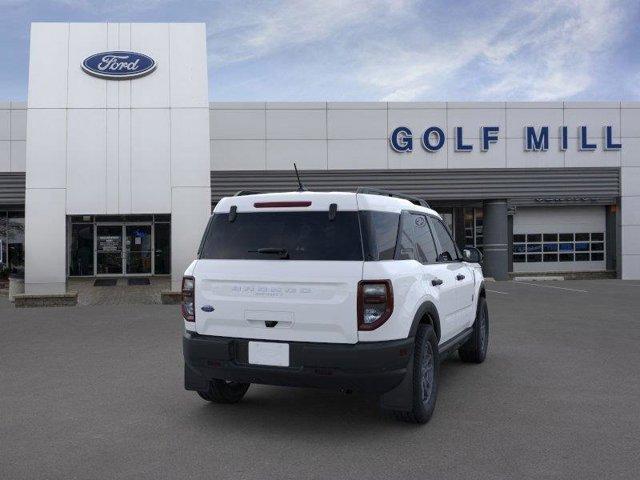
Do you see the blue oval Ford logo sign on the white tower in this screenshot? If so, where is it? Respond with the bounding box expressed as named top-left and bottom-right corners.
top-left (82, 51), bottom-right (156, 80)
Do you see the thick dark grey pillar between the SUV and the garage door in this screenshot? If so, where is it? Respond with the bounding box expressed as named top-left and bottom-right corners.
top-left (483, 200), bottom-right (509, 280)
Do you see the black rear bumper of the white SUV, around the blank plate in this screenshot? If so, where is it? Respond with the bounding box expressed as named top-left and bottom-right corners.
top-left (183, 331), bottom-right (413, 393)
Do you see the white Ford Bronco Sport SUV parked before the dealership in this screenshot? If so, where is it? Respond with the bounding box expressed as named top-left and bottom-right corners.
top-left (182, 189), bottom-right (489, 423)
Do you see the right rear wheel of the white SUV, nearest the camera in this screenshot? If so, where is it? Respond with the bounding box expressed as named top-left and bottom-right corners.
top-left (394, 324), bottom-right (439, 423)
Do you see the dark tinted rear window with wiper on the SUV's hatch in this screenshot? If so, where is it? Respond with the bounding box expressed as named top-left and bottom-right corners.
top-left (199, 211), bottom-right (363, 260)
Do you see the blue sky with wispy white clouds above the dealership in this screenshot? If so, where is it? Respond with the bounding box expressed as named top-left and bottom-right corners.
top-left (0, 0), bottom-right (640, 101)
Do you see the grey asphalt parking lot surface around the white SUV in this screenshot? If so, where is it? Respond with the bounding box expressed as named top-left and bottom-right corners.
top-left (0, 280), bottom-right (640, 479)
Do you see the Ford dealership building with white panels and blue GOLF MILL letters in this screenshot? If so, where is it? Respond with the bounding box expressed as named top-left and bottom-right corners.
top-left (0, 23), bottom-right (640, 295)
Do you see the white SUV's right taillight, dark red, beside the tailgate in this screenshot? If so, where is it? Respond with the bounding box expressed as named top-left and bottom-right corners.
top-left (358, 280), bottom-right (393, 330)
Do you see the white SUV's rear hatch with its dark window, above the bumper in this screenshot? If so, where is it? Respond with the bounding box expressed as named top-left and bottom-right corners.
top-left (194, 192), bottom-right (363, 343)
